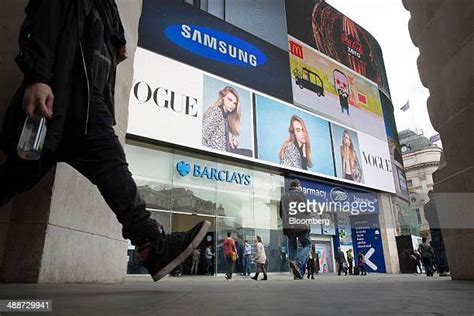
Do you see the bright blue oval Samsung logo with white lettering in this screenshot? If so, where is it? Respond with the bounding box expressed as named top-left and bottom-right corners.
top-left (165, 24), bottom-right (267, 67)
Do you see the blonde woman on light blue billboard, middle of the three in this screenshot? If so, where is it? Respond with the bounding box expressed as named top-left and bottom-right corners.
top-left (279, 115), bottom-right (313, 170)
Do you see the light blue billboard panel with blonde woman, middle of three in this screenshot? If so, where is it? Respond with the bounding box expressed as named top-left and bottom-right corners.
top-left (255, 95), bottom-right (334, 176)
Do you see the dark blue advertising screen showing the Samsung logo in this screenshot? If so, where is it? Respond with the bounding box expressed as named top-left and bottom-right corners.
top-left (138, 0), bottom-right (292, 102)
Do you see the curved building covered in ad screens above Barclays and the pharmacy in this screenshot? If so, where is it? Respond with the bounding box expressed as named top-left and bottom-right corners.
top-left (125, 0), bottom-right (395, 274)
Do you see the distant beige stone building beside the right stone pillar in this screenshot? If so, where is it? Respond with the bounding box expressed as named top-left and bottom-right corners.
top-left (398, 130), bottom-right (443, 237)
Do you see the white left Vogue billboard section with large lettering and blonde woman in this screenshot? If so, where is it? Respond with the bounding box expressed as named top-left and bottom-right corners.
top-left (128, 48), bottom-right (254, 157)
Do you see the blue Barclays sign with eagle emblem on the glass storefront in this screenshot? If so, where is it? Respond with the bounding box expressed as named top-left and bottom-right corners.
top-left (176, 161), bottom-right (252, 185)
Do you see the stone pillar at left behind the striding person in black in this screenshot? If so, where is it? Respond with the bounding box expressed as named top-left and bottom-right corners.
top-left (0, 0), bottom-right (142, 283)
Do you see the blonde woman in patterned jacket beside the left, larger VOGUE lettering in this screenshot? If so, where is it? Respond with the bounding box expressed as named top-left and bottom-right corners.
top-left (202, 86), bottom-right (241, 152)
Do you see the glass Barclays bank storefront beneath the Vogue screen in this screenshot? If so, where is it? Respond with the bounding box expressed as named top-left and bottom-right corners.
top-left (125, 141), bottom-right (288, 274)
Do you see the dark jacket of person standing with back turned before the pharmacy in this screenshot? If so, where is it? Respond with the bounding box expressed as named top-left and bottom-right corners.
top-left (280, 188), bottom-right (310, 235)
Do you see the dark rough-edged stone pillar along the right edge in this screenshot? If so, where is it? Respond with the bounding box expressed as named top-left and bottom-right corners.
top-left (403, 0), bottom-right (474, 280)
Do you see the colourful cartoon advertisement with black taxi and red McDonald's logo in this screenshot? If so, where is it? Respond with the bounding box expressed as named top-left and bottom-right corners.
top-left (288, 36), bottom-right (387, 140)
